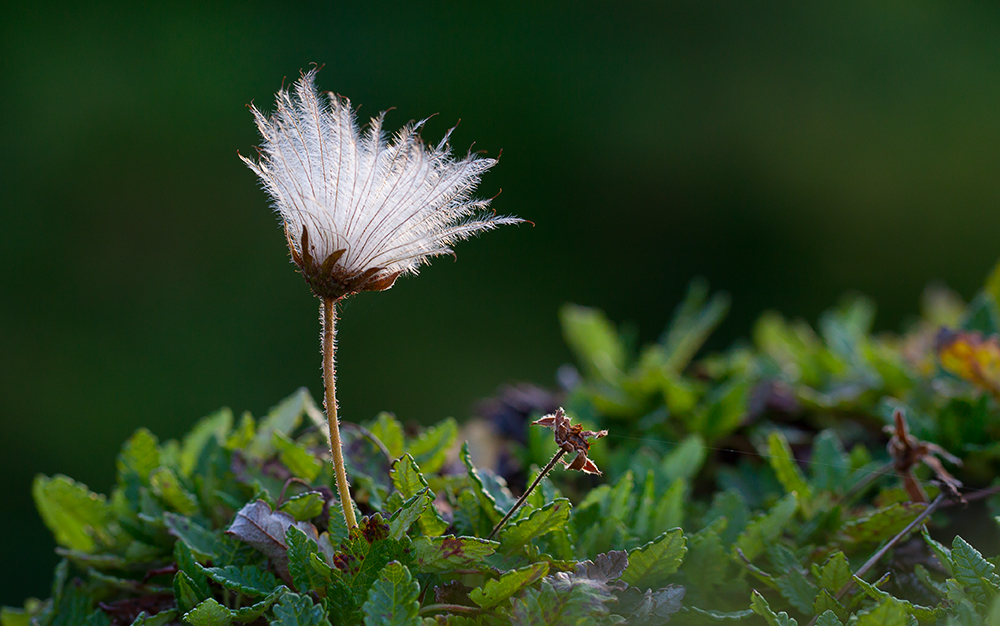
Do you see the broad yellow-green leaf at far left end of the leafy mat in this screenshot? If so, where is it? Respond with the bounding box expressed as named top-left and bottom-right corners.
top-left (31, 474), bottom-right (112, 553)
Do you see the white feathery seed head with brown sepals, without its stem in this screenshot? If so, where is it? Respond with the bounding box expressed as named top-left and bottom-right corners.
top-left (240, 70), bottom-right (523, 300)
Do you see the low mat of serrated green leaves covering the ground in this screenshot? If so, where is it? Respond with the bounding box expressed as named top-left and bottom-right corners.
top-left (9, 264), bottom-right (1000, 626)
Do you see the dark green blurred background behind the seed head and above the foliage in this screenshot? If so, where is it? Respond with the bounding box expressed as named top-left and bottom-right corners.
top-left (0, 0), bottom-right (1000, 604)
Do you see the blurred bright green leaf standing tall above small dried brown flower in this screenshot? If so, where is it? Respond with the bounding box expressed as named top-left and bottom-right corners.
top-left (559, 304), bottom-right (625, 381)
